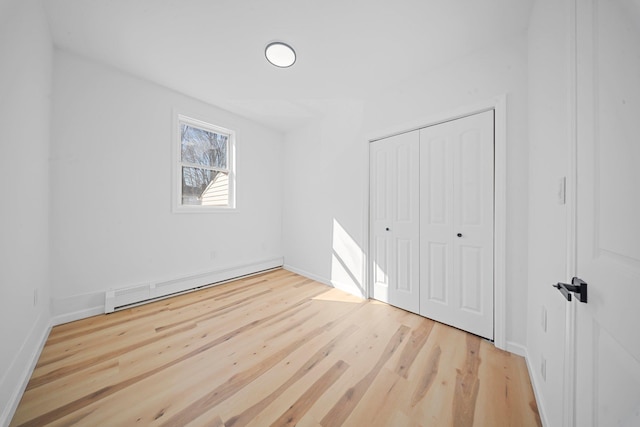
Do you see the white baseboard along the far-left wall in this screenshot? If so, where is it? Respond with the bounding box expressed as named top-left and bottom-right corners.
top-left (0, 312), bottom-right (51, 426)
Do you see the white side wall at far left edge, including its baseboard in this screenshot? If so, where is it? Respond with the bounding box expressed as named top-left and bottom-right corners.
top-left (0, 0), bottom-right (52, 425)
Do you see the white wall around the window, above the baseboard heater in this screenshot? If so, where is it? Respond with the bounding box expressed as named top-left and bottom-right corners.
top-left (51, 50), bottom-right (283, 316)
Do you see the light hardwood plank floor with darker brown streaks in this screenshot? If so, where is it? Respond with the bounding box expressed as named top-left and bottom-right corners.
top-left (11, 269), bottom-right (540, 427)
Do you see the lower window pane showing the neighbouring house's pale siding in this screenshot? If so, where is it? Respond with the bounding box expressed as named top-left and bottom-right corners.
top-left (182, 167), bottom-right (229, 206)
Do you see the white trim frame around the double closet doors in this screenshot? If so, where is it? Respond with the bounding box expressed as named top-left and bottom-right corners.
top-left (363, 94), bottom-right (510, 354)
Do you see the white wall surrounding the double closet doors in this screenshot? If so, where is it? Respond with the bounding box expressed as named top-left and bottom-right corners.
top-left (283, 34), bottom-right (528, 350)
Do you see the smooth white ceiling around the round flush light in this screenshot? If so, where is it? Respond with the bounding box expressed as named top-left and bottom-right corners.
top-left (44, 0), bottom-right (533, 131)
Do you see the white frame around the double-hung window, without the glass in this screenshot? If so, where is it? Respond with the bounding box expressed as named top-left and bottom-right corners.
top-left (172, 112), bottom-right (236, 213)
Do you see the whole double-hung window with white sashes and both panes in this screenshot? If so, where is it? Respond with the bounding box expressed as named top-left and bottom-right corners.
top-left (176, 115), bottom-right (235, 212)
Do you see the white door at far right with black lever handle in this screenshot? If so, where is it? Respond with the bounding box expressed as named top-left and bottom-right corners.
top-left (572, 0), bottom-right (640, 427)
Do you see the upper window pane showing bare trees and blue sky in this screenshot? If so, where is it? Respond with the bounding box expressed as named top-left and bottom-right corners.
top-left (180, 123), bottom-right (229, 169)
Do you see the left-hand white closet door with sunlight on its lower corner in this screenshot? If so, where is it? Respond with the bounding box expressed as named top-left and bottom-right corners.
top-left (370, 131), bottom-right (420, 313)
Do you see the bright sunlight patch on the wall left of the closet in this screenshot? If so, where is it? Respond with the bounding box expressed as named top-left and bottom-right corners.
top-left (331, 218), bottom-right (367, 298)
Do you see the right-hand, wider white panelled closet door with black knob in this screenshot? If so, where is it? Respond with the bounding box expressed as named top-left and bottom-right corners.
top-left (420, 111), bottom-right (494, 339)
